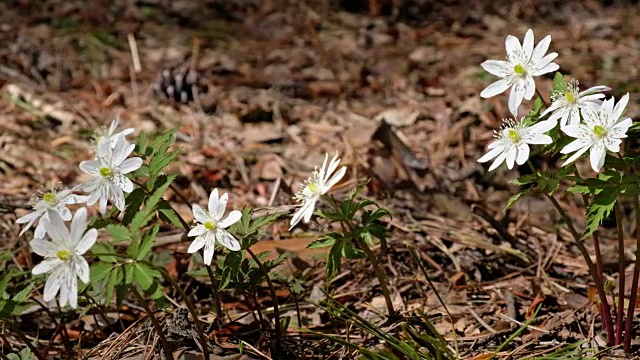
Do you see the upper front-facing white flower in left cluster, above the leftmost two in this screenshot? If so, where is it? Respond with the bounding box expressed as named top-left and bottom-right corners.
top-left (75, 136), bottom-right (142, 214)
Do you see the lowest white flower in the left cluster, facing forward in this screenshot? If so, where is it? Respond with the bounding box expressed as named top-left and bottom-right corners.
top-left (29, 208), bottom-right (98, 309)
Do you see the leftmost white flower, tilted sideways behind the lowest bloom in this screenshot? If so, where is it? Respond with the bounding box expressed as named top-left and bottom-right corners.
top-left (16, 188), bottom-right (86, 238)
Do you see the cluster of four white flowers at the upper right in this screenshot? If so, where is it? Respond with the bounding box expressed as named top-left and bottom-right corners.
top-left (478, 29), bottom-right (632, 172)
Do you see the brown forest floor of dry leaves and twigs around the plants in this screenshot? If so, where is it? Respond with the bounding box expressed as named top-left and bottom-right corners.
top-left (0, 0), bottom-right (640, 359)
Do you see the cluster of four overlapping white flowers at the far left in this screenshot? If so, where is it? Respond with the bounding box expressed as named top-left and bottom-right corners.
top-left (16, 119), bottom-right (142, 308)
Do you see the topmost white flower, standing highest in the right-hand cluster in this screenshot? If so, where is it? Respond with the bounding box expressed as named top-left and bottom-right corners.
top-left (480, 29), bottom-right (559, 117)
